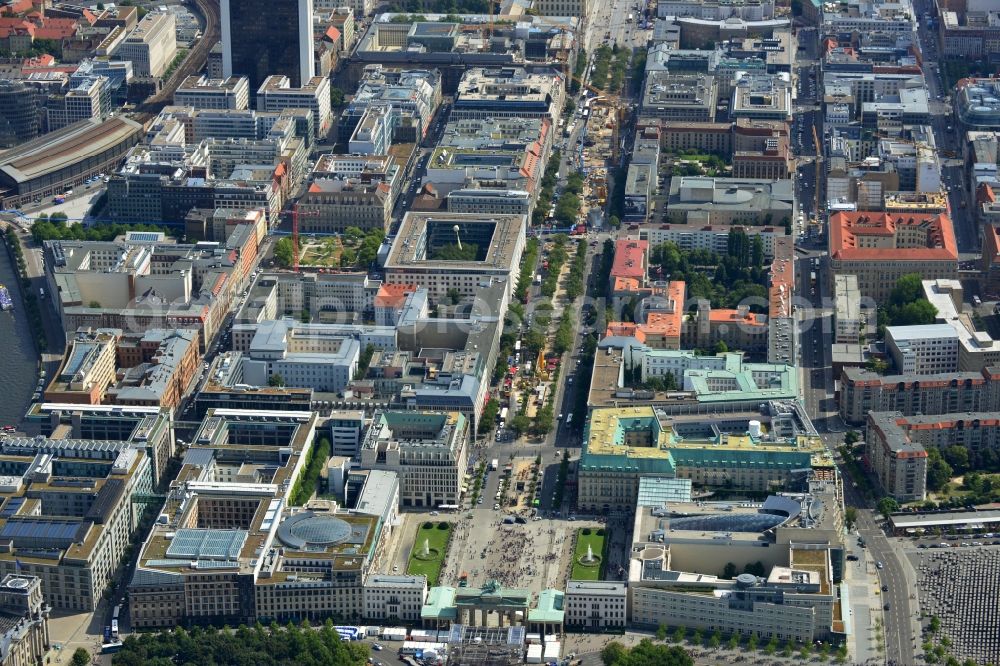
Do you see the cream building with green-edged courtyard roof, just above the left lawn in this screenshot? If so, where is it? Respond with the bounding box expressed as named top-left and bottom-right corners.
top-left (361, 411), bottom-right (470, 508)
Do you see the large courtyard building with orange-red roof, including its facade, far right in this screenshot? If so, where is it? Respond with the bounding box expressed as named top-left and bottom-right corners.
top-left (829, 211), bottom-right (958, 302)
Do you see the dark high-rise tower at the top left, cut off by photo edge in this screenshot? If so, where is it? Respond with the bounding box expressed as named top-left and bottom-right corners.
top-left (220, 0), bottom-right (314, 91)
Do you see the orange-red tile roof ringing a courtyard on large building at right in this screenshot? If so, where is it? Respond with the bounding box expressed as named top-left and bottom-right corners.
top-left (830, 211), bottom-right (958, 261)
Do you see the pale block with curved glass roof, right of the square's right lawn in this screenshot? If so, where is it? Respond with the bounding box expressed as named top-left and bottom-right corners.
top-left (628, 490), bottom-right (850, 643)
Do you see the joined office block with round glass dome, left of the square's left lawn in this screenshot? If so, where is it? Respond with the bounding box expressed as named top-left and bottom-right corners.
top-left (129, 410), bottom-right (393, 628)
